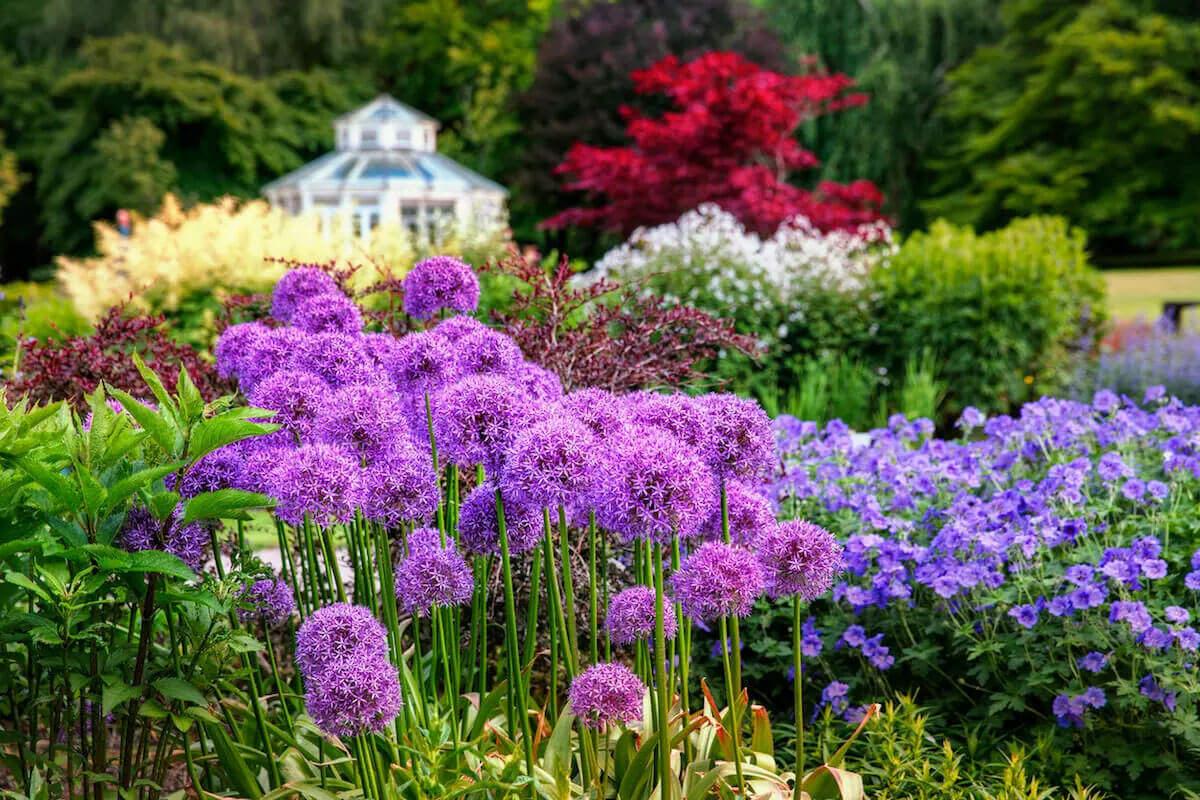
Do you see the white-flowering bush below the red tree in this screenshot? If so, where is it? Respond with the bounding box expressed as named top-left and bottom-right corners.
top-left (594, 204), bottom-right (896, 393)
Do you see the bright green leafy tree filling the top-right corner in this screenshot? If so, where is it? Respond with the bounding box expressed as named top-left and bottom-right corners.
top-left (926, 0), bottom-right (1200, 248)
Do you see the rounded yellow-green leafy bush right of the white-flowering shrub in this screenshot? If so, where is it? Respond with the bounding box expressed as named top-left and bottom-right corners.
top-left (863, 217), bottom-right (1104, 419)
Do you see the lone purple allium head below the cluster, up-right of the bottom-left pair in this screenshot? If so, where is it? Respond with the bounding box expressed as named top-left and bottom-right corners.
top-left (396, 528), bottom-right (475, 616)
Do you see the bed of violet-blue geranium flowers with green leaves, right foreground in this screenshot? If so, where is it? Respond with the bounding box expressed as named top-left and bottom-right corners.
top-left (758, 389), bottom-right (1200, 788)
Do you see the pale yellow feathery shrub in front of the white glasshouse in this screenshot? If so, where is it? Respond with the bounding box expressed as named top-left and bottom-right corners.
top-left (58, 196), bottom-right (506, 319)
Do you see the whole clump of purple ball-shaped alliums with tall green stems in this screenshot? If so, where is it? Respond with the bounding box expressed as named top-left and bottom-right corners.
top-left (93, 259), bottom-right (873, 800)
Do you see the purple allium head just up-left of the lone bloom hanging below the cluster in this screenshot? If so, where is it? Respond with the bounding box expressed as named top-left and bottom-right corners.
top-left (362, 439), bottom-right (440, 525)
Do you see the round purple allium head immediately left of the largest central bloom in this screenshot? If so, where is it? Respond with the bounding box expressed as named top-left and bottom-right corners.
top-left (500, 416), bottom-right (598, 509)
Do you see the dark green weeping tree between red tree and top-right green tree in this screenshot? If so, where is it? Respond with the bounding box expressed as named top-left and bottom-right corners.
top-left (760, 0), bottom-right (1000, 229)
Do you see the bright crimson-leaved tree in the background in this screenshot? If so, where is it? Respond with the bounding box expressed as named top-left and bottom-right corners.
top-left (542, 53), bottom-right (883, 235)
